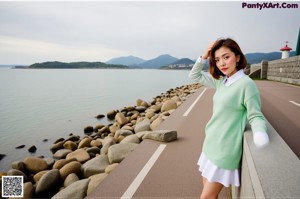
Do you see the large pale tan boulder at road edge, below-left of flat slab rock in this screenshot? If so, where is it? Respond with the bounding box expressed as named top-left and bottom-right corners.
top-left (108, 143), bottom-right (138, 164)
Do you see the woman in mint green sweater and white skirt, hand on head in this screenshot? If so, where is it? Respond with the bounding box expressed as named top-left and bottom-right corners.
top-left (189, 38), bottom-right (269, 198)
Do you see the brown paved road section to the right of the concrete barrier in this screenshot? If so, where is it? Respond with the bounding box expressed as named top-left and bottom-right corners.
top-left (256, 81), bottom-right (300, 158)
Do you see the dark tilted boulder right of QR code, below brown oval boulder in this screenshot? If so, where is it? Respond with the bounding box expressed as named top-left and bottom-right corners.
top-left (35, 169), bottom-right (60, 194)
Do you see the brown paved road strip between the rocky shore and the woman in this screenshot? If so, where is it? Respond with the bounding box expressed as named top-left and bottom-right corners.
top-left (88, 88), bottom-right (230, 198)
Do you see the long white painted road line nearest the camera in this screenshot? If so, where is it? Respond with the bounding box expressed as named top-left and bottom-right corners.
top-left (121, 144), bottom-right (167, 199)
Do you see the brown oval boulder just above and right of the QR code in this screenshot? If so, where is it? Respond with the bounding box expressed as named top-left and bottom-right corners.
top-left (23, 157), bottom-right (48, 173)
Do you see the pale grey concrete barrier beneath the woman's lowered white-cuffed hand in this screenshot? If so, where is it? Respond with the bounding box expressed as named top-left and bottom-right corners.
top-left (232, 122), bottom-right (300, 199)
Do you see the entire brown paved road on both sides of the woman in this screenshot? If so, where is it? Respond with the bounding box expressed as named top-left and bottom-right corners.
top-left (87, 81), bottom-right (300, 198)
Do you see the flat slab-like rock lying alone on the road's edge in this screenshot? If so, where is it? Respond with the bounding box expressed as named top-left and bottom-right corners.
top-left (143, 130), bottom-right (177, 142)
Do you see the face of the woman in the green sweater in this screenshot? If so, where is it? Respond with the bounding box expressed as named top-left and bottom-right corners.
top-left (215, 46), bottom-right (240, 77)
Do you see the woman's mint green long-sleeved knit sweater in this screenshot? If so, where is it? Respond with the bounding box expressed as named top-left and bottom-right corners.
top-left (189, 62), bottom-right (266, 170)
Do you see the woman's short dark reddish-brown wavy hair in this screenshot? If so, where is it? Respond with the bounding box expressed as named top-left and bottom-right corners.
top-left (209, 38), bottom-right (247, 79)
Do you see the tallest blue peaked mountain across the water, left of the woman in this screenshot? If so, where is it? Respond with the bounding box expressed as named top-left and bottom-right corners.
top-left (138, 54), bottom-right (178, 69)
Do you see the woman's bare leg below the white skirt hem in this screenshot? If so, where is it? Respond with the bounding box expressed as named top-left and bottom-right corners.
top-left (200, 177), bottom-right (223, 199)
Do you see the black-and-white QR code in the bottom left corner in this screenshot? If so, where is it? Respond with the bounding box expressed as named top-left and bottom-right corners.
top-left (1, 176), bottom-right (23, 197)
